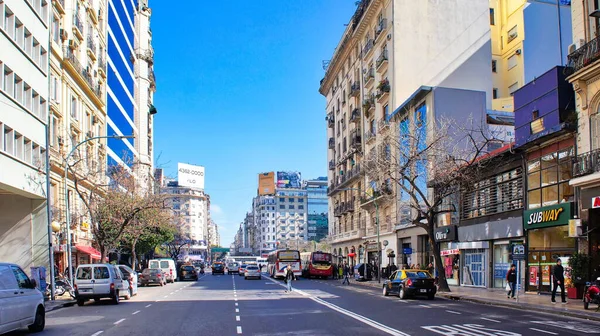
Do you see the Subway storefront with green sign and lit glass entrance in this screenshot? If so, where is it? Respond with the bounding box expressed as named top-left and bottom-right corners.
top-left (523, 202), bottom-right (577, 292)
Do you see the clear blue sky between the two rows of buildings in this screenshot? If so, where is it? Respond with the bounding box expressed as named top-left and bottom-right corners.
top-left (150, 0), bottom-right (356, 246)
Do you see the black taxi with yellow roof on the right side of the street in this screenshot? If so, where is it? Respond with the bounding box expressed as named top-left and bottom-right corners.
top-left (383, 269), bottom-right (437, 300)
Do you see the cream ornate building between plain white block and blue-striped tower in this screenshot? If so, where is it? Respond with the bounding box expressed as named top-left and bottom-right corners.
top-left (48, 0), bottom-right (106, 271)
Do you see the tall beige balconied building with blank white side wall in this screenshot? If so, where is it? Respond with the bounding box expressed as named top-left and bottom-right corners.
top-left (320, 0), bottom-right (492, 267)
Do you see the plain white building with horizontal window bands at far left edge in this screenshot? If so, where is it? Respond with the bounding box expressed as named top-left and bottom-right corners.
top-left (0, 1), bottom-right (51, 269)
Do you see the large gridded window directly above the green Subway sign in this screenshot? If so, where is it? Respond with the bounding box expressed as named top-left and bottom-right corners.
top-left (527, 147), bottom-right (574, 209)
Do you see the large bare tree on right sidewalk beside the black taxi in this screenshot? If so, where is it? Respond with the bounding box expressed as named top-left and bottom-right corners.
top-left (365, 112), bottom-right (497, 291)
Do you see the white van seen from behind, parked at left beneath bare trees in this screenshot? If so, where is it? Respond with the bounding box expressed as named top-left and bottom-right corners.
top-left (75, 264), bottom-right (129, 306)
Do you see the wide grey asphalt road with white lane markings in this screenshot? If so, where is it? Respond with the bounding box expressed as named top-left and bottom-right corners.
top-left (9, 274), bottom-right (600, 336)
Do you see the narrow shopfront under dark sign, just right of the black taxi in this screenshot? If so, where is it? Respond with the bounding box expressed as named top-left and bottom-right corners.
top-left (434, 225), bottom-right (460, 286)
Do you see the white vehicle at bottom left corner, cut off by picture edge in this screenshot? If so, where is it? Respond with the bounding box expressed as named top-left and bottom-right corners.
top-left (0, 263), bottom-right (46, 334)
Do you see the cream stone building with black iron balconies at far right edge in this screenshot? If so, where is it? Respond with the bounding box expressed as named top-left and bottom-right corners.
top-left (567, 0), bottom-right (600, 265)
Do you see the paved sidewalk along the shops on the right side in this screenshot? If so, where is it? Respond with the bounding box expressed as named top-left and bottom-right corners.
top-left (352, 280), bottom-right (600, 321)
